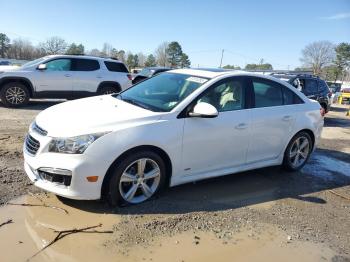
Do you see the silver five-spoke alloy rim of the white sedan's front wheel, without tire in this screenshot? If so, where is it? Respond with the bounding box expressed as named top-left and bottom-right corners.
top-left (119, 158), bottom-right (161, 204)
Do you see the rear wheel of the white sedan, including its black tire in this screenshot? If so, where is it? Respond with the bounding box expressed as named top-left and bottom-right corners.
top-left (283, 131), bottom-right (313, 171)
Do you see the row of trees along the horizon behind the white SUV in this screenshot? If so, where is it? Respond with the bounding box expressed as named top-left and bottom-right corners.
top-left (0, 33), bottom-right (191, 69)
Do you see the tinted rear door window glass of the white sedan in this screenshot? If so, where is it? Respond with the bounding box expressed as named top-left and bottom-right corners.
top-left (252, 78), bottom-right (283, 107)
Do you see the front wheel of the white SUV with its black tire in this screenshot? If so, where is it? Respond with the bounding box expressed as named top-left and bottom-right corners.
top-left (0, 82), bottom-right (30, 107)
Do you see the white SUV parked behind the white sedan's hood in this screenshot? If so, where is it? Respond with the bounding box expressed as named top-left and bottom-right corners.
top-left (0, 55), bottom-right (132, 107)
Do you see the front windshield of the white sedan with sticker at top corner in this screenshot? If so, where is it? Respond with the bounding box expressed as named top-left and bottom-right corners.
top-left (113, 73), bottom-right (208, 112)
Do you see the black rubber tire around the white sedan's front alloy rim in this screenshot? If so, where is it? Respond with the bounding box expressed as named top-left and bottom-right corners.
top-left (107, 151), bottom-right (166, 206)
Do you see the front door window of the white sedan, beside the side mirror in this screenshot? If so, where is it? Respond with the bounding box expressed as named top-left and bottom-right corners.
top-left (197, 79), bottom-right (245, 112)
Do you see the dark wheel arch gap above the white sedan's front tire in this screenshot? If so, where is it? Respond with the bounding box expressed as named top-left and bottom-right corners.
top-left (101, 145), bottom-right (173, 198)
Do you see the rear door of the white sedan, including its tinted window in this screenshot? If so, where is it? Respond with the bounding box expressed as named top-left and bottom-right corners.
top-left (247, 77), bottom-right (296, 163)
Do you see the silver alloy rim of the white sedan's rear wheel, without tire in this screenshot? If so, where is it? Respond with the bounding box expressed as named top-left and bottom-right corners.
top-left (289, 136), bottom-right (310, 168)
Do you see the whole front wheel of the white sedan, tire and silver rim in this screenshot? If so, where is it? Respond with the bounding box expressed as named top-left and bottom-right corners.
top-left (108, 151), bottom-right (166, 206)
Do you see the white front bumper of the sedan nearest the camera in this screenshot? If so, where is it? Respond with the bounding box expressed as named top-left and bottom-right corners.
top-left (23, 132), bottom-right (108, 200)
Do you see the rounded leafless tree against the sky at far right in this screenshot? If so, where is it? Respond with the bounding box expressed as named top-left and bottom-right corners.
top-left (300, 41), bottom-right (335, 75)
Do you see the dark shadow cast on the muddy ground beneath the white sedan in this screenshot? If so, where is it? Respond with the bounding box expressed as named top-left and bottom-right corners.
top-left (59, 150), bottom-right (350, 215)
